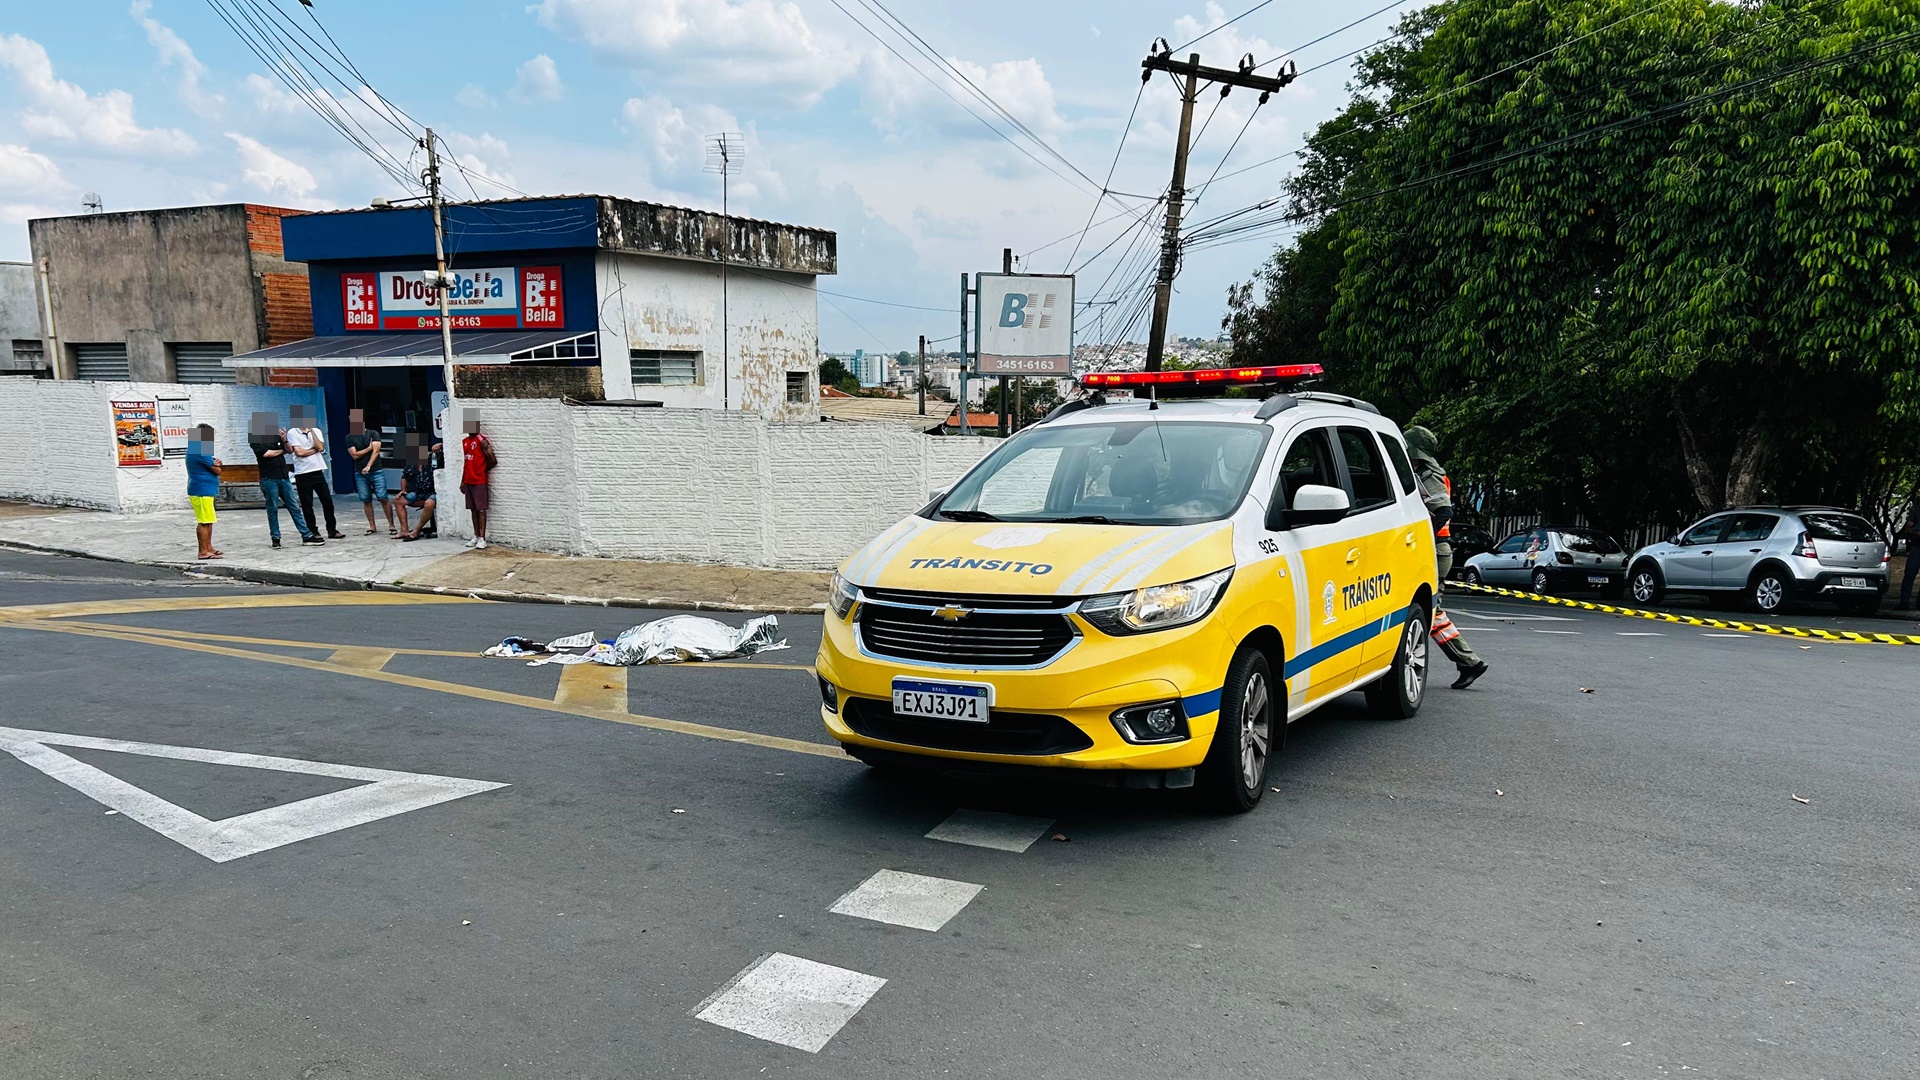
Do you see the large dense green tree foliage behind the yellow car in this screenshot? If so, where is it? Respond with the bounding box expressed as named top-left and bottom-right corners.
top-left (1225, 0), bottom-right (1920, 523)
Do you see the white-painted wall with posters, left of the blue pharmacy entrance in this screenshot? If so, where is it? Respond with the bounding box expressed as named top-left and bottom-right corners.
top-left (0, 377), bottom-right (324, 513)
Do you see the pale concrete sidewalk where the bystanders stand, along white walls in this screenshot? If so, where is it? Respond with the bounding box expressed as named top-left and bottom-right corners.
top-left (0, 502), bottom-right (831, 611)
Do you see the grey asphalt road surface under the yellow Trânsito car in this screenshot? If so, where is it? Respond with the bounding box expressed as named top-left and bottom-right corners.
top-left (0, 553), bottom-right (1920, 1080)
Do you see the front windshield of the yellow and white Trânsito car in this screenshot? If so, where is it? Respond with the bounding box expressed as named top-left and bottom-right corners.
top-left (929, 421), bottom-right (1273, 525)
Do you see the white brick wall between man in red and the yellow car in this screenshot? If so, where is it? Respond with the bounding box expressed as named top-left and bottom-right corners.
top-left (436, 400), bottom-right (998, 569)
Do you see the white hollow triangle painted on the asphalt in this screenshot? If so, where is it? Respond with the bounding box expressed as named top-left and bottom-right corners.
top-left (0, 728), bottom-right (507, 863)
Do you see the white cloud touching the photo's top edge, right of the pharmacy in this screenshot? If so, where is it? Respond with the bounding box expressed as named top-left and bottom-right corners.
top-left (534, 0), bottom-right (852, 106)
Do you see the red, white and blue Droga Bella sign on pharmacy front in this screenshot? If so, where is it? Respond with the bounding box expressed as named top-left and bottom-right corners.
top-left (340, 267), bottom-right (566, 331)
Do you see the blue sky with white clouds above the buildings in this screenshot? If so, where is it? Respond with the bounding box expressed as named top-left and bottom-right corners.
top-left (0, 0), bottom-right (1419, 352)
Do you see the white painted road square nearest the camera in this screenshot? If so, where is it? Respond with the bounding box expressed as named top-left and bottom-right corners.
top-left (693, 953), bottom-right (887, 1053)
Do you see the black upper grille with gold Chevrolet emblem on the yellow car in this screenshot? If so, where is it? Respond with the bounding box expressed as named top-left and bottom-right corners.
top-left (856, 592), bottom-right (1075, 667)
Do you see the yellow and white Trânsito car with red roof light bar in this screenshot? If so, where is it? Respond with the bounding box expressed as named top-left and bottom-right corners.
top-left (816, 365), bottom-right (1438, 811)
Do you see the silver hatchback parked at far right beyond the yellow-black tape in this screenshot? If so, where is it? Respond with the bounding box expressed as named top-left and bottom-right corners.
top-left (1626, 505), bottom-right (1887, 615)
